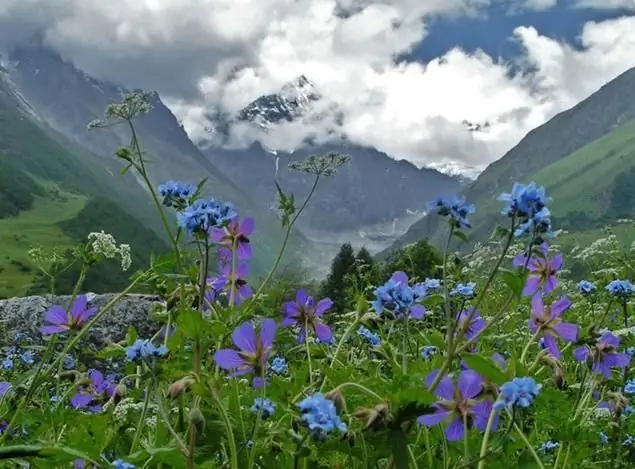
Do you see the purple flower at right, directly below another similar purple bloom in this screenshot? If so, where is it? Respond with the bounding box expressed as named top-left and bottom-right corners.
top-left (529, 295), bottom-right (578, 359)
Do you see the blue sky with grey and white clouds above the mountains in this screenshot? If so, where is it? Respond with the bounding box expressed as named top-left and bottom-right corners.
top-left (0, 0), bottom-right (635, 173)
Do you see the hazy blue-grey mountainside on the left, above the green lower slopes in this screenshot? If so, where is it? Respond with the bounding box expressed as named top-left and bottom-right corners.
top-left (4, 40), bottom-right (307, 273)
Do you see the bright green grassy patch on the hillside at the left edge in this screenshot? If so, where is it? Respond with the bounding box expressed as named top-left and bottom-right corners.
top-left (0, 184), bottom-right (88, 297)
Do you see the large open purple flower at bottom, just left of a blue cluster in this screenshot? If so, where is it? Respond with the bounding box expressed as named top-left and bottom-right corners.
top-left (417, 370), bottom-right (498, 441)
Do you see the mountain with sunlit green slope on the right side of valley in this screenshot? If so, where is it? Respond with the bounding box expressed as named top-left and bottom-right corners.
top-left (386, 65), bottom-right (635, 252)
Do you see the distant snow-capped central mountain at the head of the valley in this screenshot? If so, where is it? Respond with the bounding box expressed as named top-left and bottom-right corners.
top-left (201, 76), bottom-right (460, 250)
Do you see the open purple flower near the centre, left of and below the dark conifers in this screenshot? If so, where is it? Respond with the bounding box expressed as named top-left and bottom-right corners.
top-left (282, 289), bottom-right (333, 343)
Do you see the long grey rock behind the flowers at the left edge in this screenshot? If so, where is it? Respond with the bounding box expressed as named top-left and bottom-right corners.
top-left (0, 293), bottom-right (166, 349)
